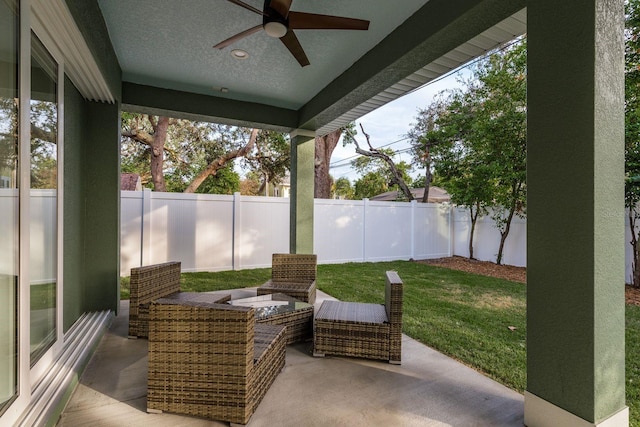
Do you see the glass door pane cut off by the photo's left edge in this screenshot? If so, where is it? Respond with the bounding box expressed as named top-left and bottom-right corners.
top-left (0, 0), bottom-right (19, 414)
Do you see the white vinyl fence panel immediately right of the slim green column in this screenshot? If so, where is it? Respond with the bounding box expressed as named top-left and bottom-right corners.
top-left (313, 199), bottom-right (365, 264)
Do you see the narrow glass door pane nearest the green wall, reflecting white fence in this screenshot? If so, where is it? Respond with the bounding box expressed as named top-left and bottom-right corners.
top-left (29, 35), bottom-right (58, 366)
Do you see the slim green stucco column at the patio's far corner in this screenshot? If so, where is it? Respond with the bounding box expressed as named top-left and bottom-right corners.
top-left (289, 129), bottom-right (315, 254)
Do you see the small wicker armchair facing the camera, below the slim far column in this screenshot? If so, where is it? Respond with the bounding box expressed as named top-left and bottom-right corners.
top-left (258, 254), bottom-right (318, 304)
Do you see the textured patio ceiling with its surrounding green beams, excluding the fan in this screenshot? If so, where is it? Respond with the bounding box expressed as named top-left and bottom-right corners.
top-left (95, 0), bottom-right (526, 135)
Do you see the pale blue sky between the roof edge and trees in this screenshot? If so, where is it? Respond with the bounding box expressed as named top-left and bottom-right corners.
top-left (329, 68), bottom-right (468, 183)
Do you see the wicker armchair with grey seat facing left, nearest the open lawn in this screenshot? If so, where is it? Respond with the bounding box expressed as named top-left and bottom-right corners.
top-left (313, 271), bottom-right (403, 365)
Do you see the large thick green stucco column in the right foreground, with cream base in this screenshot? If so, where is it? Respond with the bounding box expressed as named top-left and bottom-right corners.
top-left (525, 0), bottom-right (628, 427)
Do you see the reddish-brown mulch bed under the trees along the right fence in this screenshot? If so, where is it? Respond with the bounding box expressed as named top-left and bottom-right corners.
top-left (416, 256), bottom-right (640, 306)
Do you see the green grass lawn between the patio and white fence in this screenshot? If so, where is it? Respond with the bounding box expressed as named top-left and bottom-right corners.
top-left (121, 261), bottom-right (640, 427)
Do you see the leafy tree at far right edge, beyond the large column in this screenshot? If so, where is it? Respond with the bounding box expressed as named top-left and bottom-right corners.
top-left (624, 0), bottom-right (640, 287)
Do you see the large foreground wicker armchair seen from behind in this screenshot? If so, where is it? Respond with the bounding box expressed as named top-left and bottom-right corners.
top-left (147, 299), bottom-right (286, 424)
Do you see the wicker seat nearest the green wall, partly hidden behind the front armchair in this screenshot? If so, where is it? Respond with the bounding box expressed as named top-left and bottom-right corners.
top-left (128, 261), bottom-right (231, 338)
